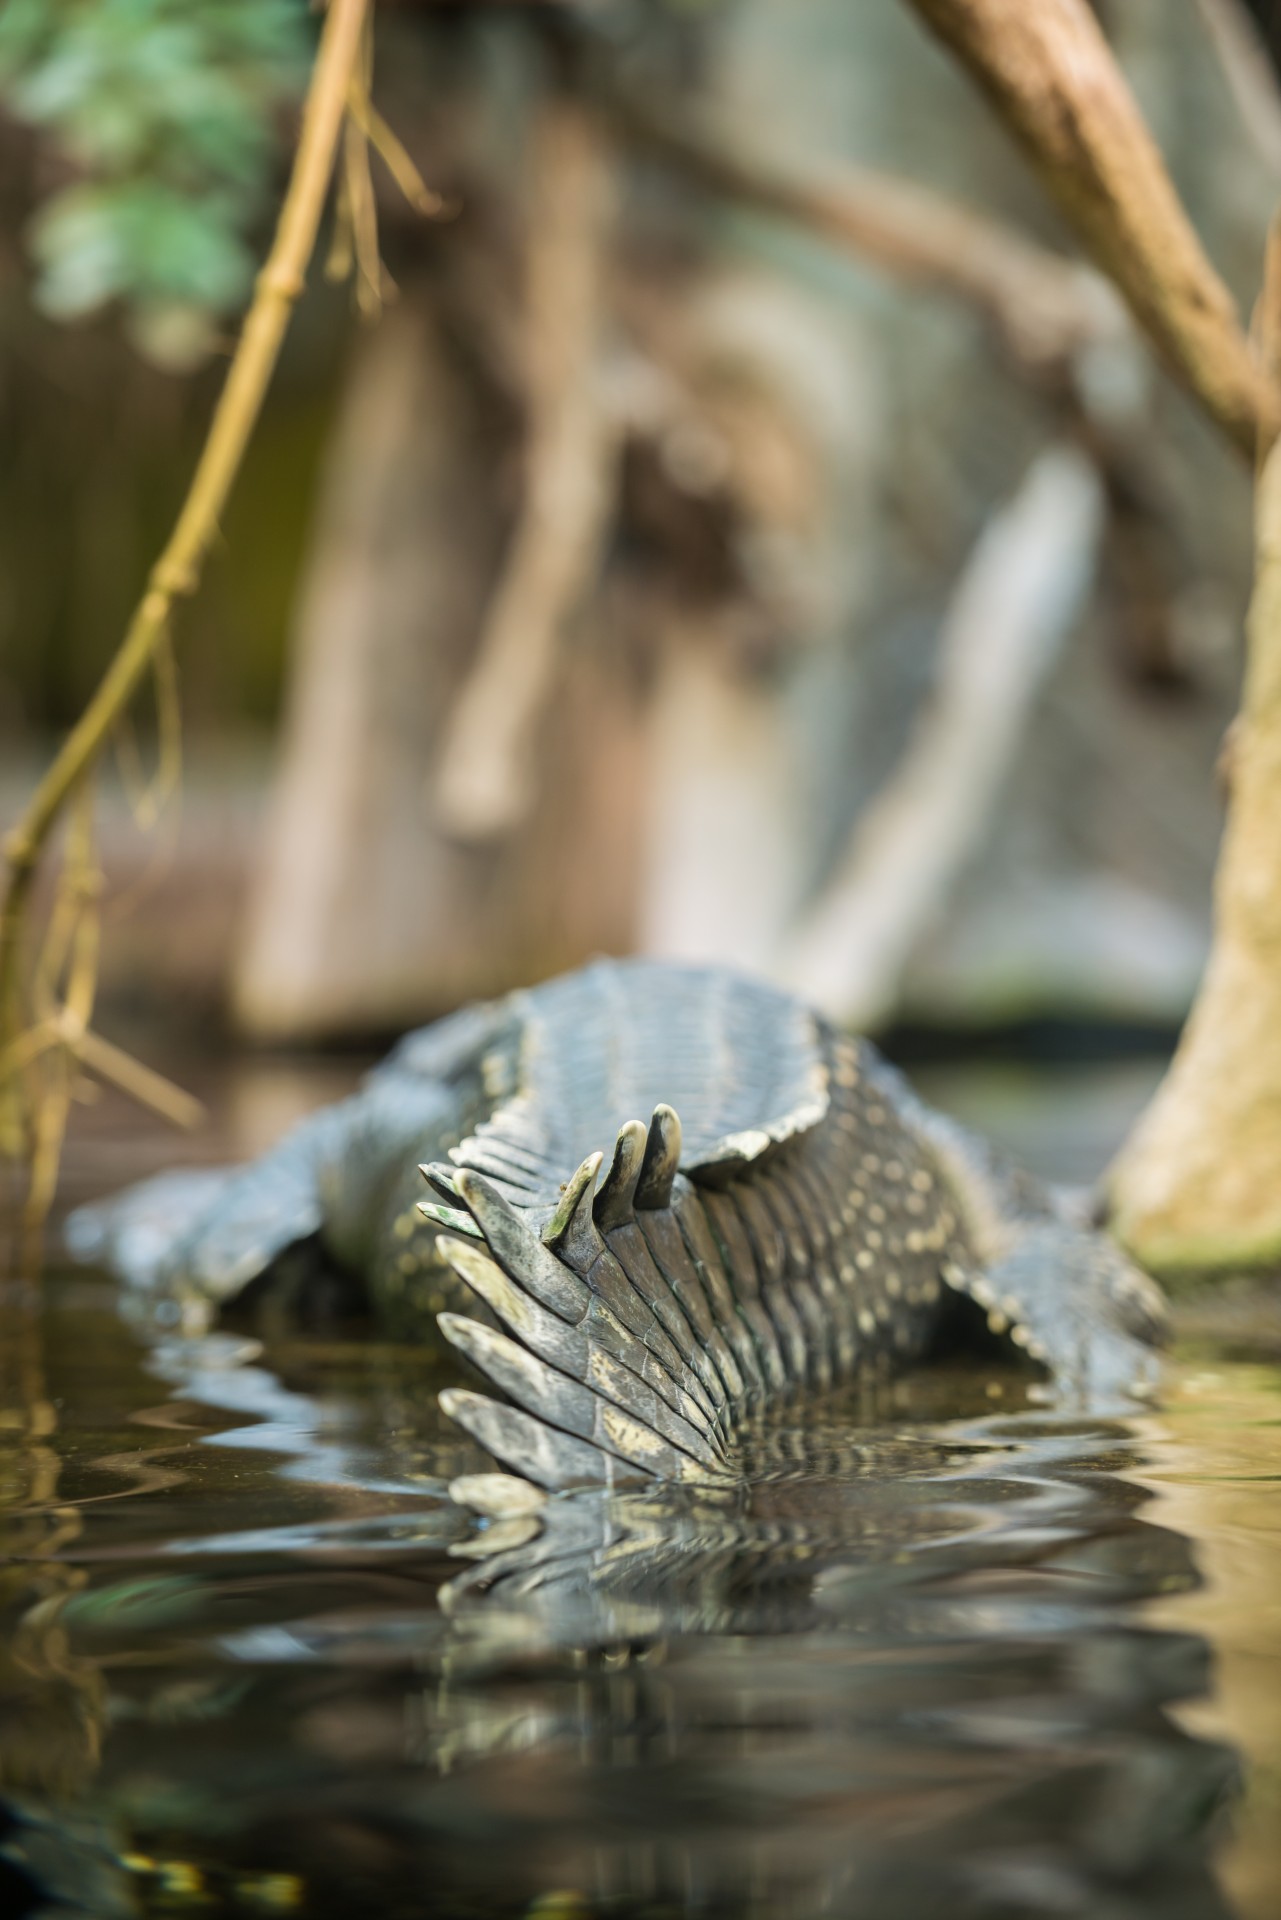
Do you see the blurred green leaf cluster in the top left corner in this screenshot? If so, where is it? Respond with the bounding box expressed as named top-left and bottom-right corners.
top-left (0, 0), bottom-right (313, 357)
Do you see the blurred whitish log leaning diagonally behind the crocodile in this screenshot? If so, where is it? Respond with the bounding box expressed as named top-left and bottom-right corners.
top-left (782, 445), bottom-right (1104, 1027)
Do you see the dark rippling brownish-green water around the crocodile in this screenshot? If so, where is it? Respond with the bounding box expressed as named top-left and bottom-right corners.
top-left (0, 1068), bottom-right (1281, 1920)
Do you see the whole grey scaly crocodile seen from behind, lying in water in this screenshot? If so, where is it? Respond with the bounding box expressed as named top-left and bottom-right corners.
top-left (69, 960), bottom-right (1164, 1513)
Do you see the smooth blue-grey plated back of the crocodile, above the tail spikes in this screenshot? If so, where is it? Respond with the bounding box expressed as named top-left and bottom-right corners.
top-left (451, 960), bottom-right (828, 1219)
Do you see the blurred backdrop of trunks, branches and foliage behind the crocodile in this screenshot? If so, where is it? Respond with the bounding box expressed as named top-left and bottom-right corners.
top-left (0, 0), bottom-right (1281, 1067)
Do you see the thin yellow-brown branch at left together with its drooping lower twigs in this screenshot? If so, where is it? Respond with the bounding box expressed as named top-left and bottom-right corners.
top-left (0, 0), bottom-right (371, 1223)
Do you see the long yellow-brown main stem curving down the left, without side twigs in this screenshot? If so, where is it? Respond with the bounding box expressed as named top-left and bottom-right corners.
top-left (0, 0), bottom-right (371, 1039)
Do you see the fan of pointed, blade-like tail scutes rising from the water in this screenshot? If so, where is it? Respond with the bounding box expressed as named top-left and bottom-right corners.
top-left (434, 1106), bottom-right (764, 1490)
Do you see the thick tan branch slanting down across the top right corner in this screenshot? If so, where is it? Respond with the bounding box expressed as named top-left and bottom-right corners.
top-left (908, 0), bottom-right (1281, 459)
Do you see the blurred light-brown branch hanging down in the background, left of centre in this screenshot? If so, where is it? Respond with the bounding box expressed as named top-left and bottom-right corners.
top-left (436, 100), bottom-right (616, 841)
